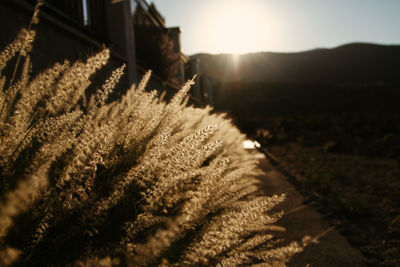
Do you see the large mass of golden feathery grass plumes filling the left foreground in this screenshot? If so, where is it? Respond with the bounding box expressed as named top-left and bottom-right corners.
top-left (0, 13), bottom-right (307, 266)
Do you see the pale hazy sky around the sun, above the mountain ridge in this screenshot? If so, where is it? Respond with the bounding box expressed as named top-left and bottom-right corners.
top-left (148, 0), bottom-right (400, 55)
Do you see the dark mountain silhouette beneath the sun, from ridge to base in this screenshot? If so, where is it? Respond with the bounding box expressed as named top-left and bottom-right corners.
top-left (192, 43), bottom-right (400, 117)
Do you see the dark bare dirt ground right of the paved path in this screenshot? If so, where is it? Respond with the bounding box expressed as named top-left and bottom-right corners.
top-left (264, 146), bottom-right (400, 267)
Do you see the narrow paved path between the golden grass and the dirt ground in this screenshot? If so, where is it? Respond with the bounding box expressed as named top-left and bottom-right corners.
top-left (258, 155), bottom-right (366, 267)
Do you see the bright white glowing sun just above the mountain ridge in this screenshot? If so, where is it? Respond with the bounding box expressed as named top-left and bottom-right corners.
top-left (198, 0), bottom-right (271, 54)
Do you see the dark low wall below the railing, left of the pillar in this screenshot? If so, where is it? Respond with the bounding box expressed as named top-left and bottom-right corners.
top-left (0, 1), bottom-right (129, 96)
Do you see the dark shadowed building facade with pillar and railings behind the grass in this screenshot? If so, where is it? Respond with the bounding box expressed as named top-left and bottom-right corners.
top-left (0, 0), bottom-right (211, 104)
